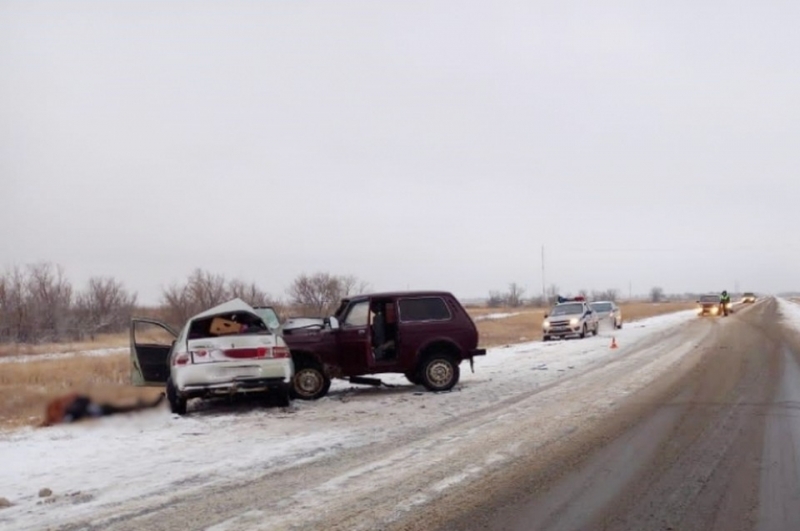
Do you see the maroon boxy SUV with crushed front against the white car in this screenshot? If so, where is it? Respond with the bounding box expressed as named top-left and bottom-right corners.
top-left (282, 291), bottom-right (486, 400)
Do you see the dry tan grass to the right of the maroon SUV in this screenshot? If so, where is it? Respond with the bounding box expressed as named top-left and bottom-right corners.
top-left (468, 302), bottom-right (694, 348)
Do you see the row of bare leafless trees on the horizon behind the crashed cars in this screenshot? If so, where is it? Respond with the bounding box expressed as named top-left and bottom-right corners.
top-left (0, 262), bottom-right (370, 343)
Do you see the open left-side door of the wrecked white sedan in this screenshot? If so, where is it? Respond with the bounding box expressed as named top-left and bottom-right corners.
top-left (131, 318), bottom-right (178, 387)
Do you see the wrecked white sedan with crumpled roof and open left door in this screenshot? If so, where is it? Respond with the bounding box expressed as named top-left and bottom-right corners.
top-left (130, 299), bottom-right (294, 415)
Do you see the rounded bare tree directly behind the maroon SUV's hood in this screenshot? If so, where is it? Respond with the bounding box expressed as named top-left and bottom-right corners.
top-left (287, 272), bottom-right (369, 317)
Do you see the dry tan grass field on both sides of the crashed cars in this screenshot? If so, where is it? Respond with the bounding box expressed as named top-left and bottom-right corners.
top-left (0, 303), bottom-right (693, 429)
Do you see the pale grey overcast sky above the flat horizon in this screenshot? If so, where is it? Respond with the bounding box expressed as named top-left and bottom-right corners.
top-left (0, 0), bottom-right (800, 303)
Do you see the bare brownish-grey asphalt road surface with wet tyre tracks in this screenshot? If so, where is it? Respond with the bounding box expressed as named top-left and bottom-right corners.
top-left (416, 300), bottom-right (800, 531)
